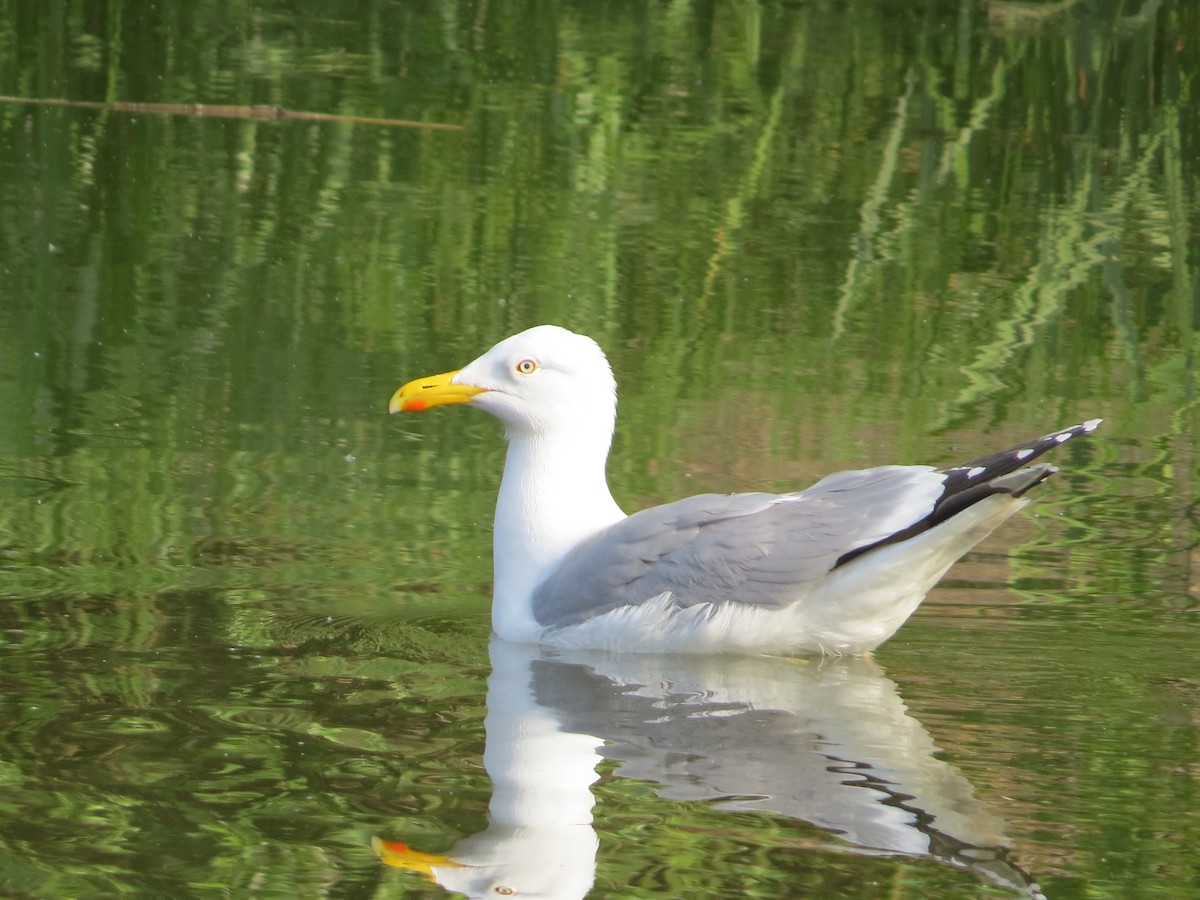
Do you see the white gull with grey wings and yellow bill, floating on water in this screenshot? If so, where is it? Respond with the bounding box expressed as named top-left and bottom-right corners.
top-left (389, 325), bottom-right (1100, 655)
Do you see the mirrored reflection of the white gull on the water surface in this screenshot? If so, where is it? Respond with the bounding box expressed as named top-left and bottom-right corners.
top-left (372, 641), bottom-right (1040, 899)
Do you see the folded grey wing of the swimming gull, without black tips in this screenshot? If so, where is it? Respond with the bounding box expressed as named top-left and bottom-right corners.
top-left (533, 466), bottom-right (946, 628)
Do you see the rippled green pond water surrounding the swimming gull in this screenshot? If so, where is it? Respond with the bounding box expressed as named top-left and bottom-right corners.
top-left (0, 0), bottom-right (1200, 899)
